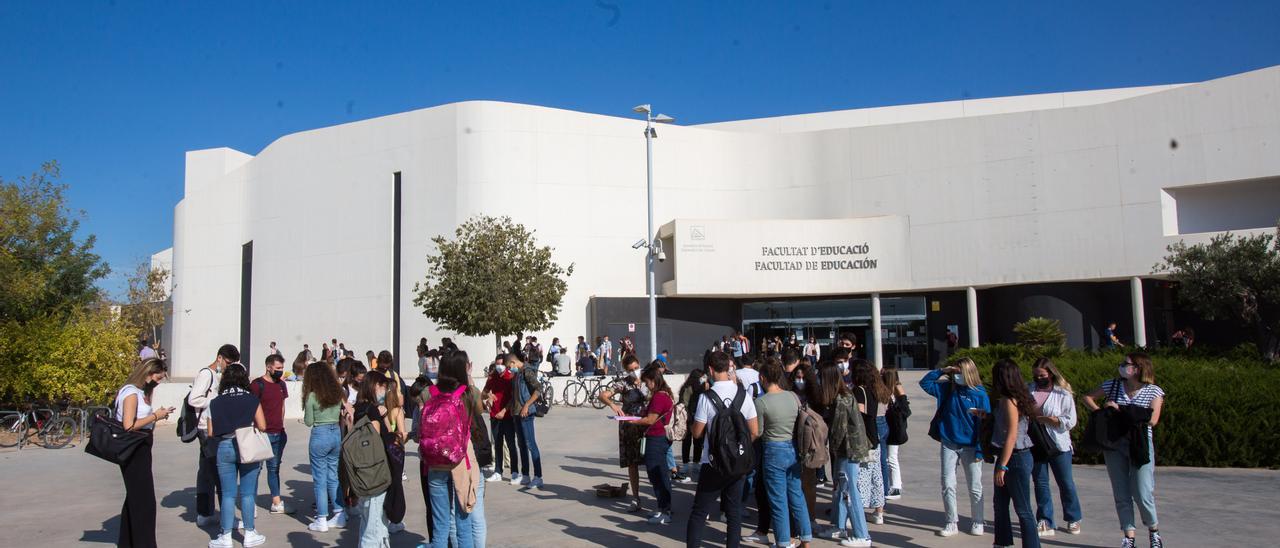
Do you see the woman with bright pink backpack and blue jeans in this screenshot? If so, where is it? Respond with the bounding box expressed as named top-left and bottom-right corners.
top-left (419, 350), bottom-right (485, 548)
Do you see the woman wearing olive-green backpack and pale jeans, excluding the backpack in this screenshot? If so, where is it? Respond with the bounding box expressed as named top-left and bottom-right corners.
top-left (355, 371), bottom-right (394, 547)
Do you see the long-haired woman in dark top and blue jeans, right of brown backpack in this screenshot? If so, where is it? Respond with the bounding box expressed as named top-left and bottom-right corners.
top-left (810, 361), bottom-right (872, 547)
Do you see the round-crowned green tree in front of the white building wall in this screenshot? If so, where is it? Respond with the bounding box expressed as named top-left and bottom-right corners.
top-left (413, 215), bottom-right (573, 338)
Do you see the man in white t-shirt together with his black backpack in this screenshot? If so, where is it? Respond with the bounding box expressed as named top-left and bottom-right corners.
top-left (685, 352), bottom-right (759, 548)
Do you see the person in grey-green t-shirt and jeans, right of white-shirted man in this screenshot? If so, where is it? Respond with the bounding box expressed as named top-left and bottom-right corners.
top-left (755, 357), bottom-right (826, 548)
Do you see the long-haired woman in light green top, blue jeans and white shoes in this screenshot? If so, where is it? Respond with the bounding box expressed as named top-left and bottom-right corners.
top-left (302, 361), bottom-right (347, 533)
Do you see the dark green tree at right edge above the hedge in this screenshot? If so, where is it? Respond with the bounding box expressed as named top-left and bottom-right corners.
top-left (1155, 224), bottom-right (1280, 364)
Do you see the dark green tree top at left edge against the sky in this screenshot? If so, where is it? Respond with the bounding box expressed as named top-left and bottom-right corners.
top-left (0, 161), bottom-right (110, 321)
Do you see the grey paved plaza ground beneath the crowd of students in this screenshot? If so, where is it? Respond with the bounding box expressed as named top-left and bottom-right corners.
top-left (0, 374), bottom-right (1280, 548)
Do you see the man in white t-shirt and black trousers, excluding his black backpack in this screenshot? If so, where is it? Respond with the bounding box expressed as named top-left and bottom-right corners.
top-left (685, 352), bottom-right (760, 547)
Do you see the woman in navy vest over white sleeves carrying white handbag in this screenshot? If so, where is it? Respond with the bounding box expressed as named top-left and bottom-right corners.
top-left (209, 364), bottom-right (266, 548)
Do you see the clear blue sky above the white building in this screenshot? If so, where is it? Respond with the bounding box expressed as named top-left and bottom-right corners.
top-left (0, 0), bottom-right (1280, 297)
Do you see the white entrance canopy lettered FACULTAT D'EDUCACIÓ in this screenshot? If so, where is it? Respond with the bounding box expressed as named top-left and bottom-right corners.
top-left (657, 215), bottom-right (911, 297)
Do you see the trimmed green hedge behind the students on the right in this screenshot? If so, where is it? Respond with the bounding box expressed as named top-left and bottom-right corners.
top-left (956, 344), bottom-right (1280, 469)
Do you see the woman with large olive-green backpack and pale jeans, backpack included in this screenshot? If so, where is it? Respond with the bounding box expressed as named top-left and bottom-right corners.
top-left (342, 371), bottom-right (394, 547)
